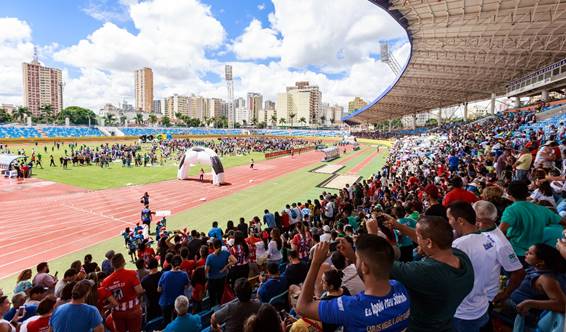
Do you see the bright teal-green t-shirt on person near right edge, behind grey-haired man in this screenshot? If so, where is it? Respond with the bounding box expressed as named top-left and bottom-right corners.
top-left (501, 201), bottom-right (560, 256)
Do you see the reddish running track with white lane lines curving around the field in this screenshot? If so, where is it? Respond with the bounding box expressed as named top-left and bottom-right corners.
top-left (0, 149), bottom-right (365, 279)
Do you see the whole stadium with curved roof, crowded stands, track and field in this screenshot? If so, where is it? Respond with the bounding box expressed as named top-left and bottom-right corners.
top-left (0, 0), bottom-right (566, 332)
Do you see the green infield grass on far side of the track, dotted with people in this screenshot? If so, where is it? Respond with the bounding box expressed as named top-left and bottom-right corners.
top-left (5, 141), bottom-right (265, 190)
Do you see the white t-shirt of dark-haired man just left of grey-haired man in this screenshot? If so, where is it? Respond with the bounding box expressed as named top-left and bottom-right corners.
top-left (452, 233), bottom-right (499, 320)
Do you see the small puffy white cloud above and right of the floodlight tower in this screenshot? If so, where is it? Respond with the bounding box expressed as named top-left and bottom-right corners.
top-left (231, 19), bottom-right (281, 60)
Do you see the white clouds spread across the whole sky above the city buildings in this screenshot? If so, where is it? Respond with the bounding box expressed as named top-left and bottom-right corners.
top-left (0, 0), bottom-right (410, 110)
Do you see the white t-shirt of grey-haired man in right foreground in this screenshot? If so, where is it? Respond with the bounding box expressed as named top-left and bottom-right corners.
top-left (482, 227), bottom-right (523, 301)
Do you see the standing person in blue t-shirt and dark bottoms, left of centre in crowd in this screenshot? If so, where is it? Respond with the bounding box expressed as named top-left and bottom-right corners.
top-left (206, 239), bottom-right (236, 305)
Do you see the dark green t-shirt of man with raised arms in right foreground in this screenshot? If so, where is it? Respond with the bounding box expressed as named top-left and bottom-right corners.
top-left (391, 248), bottom-right (474, 332)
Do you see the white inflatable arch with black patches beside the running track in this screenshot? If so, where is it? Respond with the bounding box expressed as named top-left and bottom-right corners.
top-left (177, 146), bottom-right (224, 186)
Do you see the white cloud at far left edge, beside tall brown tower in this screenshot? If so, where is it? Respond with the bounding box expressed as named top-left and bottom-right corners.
top-left (0, 18), bottom-right (33, 105)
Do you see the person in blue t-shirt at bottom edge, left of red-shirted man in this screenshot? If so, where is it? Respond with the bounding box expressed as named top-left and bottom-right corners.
top-left (49, 280), bottom-right (104, 332)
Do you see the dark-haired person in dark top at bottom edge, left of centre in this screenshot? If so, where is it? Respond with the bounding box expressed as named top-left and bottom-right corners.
top-left (210, 278), bottom-right (261, 332)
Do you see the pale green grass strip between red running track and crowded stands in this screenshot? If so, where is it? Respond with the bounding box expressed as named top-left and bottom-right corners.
top-left (0, 139), bottom-right (387, 293)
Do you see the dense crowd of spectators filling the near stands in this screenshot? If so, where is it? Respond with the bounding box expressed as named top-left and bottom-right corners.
top-left (0, 112), bottom-right (566, 332)
